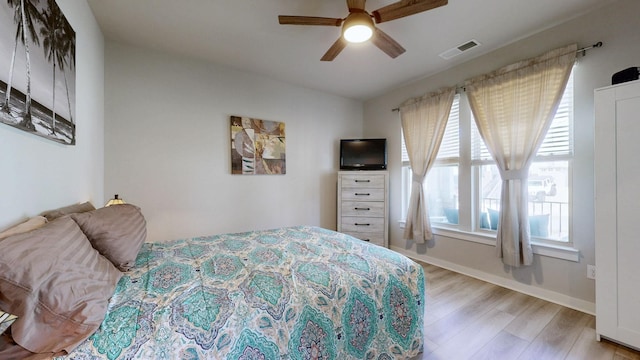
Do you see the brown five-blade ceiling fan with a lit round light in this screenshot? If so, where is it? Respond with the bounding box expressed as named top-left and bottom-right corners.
top-left (278, 0), bottom-right (448, 61)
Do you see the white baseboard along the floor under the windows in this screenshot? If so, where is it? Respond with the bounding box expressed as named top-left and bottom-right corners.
top-left (391, 246), bottom-right (596, 315)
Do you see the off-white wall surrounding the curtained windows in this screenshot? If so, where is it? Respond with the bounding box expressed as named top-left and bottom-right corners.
top-left (364, 0), bottom-right (640, 311)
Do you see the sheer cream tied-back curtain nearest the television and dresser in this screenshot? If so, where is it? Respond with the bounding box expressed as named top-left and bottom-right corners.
top-left (400, 87), bottom-right (455, 244)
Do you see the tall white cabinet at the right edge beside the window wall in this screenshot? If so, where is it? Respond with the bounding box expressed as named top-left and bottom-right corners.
top-left (594, 81), bottom-right (640, 348)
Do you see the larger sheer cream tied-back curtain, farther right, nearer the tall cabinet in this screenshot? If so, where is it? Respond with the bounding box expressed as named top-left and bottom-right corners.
top-left (465, 44), bottom-right (577, 267)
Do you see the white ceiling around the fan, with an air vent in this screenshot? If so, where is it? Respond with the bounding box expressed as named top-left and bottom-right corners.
top-left (88, 0), bottom-right (611, 100)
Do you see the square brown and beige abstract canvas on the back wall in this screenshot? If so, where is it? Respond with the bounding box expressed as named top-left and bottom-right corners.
top-left (231, 116), bottom-right (287, 175)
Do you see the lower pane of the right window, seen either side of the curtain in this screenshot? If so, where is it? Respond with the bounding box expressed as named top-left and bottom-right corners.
top-left (479, 160), bottom-right (569, 241)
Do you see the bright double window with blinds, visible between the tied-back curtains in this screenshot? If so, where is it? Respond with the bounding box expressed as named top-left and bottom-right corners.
top-left (402, 74), bottom-right (573, 244)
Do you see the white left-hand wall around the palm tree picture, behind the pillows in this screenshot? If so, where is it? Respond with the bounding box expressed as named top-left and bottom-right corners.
top-left (0, 0), bottom-right (104, 229)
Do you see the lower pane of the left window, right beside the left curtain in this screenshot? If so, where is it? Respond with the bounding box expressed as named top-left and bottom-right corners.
top-left (425, 165), bottom-right (458, 224)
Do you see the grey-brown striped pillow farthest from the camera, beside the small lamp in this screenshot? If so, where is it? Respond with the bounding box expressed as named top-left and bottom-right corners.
top-left (71, 204), bottom-right (147, 271)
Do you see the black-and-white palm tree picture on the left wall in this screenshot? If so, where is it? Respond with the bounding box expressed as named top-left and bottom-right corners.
top-left (0, 0), bottom-right (76, 145)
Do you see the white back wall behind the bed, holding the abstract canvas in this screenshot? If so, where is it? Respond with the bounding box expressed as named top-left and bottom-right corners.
top-left (105, 42), bottom-right (362, 241)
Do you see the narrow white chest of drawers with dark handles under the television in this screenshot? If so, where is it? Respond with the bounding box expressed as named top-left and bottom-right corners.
top-left (338, 171), bottom-right (389, 247)
